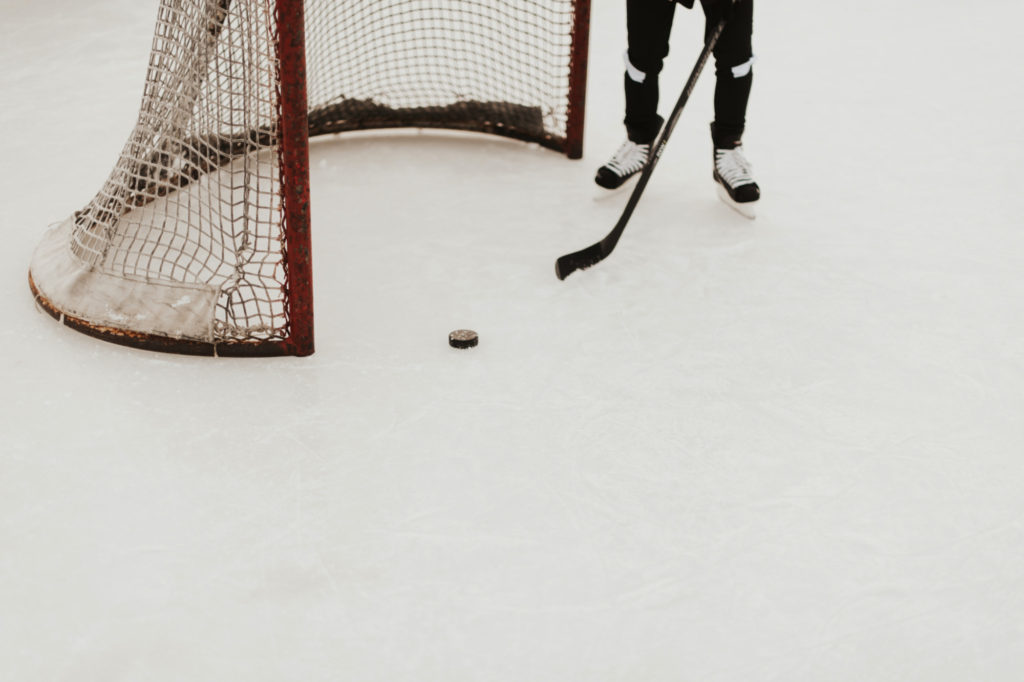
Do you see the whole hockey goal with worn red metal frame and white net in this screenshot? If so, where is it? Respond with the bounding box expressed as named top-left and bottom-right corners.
top-left (29, 0), bottom-right (590, 355)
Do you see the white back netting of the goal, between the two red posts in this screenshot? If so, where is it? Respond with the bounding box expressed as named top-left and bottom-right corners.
top-left (299, 0), bottom-right (575, 145)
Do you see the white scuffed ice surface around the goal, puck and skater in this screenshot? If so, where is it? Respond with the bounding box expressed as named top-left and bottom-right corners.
top-left (0, 0), bottom-right (1024, 682)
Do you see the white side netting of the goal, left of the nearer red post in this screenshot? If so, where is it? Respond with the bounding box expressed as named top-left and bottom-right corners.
top-left (72, 0), bottom-right (287, 341)
